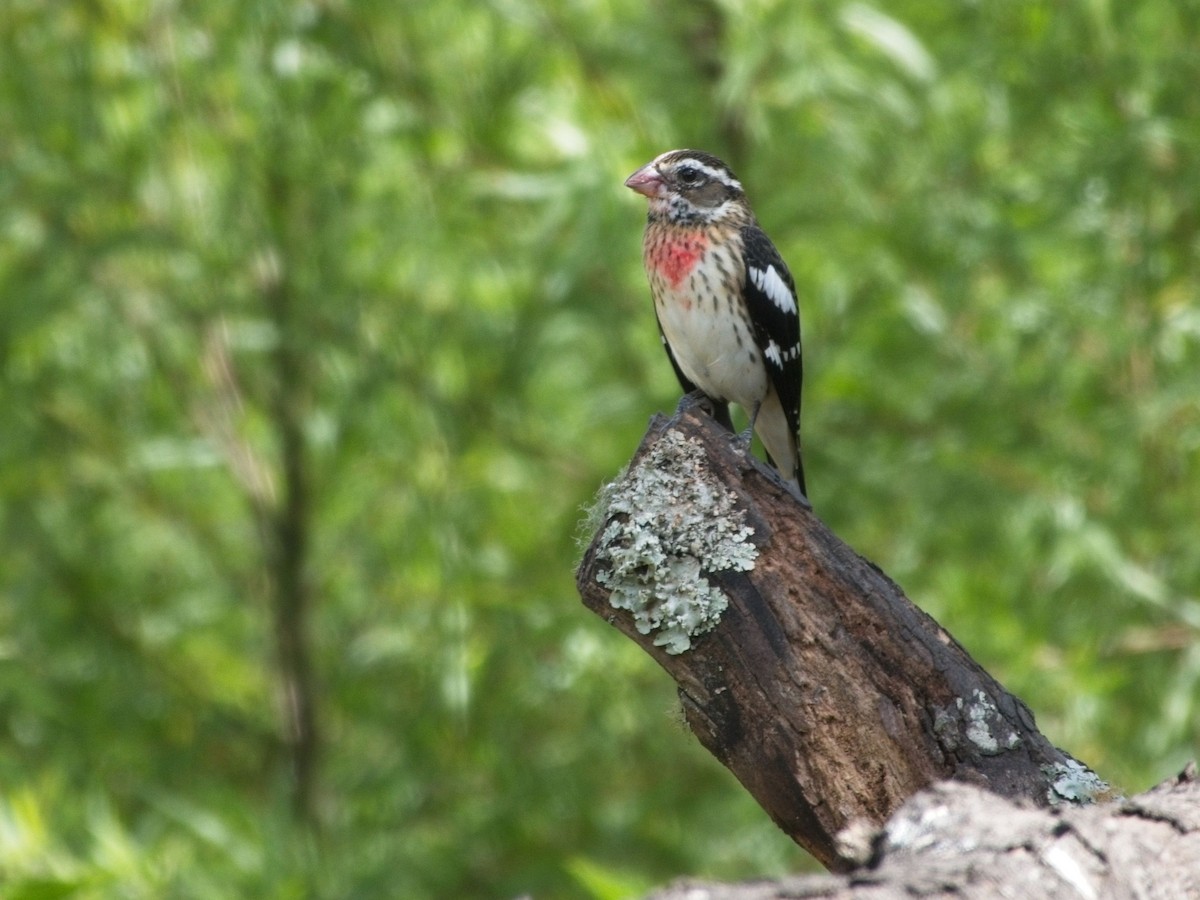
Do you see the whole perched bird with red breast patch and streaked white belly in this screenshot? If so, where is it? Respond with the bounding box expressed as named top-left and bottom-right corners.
top-left (625, 150), bottom-right (808, 496)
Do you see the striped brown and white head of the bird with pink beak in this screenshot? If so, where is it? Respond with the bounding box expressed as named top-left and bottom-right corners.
top-left (625, 150), bottom-right (745, 224)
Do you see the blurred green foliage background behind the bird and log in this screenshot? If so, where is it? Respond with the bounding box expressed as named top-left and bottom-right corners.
top-left (0, 0), bottom-right (1200, 899)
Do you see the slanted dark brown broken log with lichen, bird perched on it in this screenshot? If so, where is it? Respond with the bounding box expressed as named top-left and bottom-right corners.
top-left (577, 398), bottom-right (1108, 871)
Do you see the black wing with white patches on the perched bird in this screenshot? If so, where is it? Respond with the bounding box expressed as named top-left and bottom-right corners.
top-left (742, 223), bottom-right (808, 496)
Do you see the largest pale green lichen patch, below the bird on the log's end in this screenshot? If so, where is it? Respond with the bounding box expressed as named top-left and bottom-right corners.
top-left (596, 431), bottom-right (758, 654)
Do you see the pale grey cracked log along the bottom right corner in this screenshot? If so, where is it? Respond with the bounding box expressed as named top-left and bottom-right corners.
top-left (652, 766), bottom-right (1200, 900)
